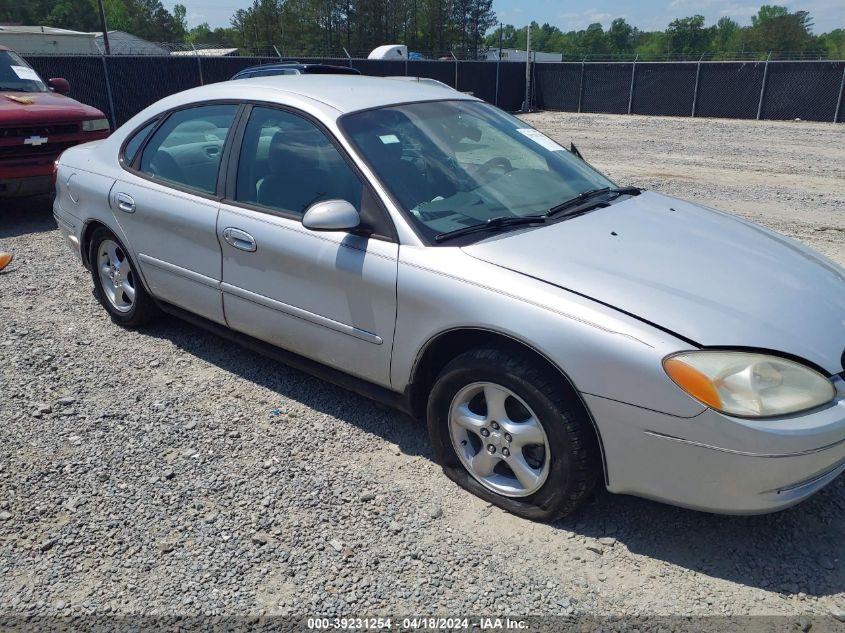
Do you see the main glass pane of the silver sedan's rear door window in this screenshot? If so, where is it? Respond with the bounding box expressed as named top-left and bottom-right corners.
top-left (138, 104), bottom-right (238, 194)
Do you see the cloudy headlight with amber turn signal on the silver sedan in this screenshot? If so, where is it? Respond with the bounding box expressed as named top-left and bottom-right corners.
top-left (663, 351), bottom-right (836, 417)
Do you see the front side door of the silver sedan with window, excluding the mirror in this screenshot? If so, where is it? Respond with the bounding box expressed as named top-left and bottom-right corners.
top-left (217, 106), bottom-right (399, 386)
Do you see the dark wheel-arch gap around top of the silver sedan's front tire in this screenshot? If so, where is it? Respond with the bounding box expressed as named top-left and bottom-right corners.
top-left (407, 327), bottom-right (608, 484)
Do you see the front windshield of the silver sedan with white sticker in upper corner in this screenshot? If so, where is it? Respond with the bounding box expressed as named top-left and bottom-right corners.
top-left (341, 101), bottom-right (614, 239)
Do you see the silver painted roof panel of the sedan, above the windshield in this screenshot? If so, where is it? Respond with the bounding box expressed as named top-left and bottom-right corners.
top-left (184, 75), bottom-right (478, 114)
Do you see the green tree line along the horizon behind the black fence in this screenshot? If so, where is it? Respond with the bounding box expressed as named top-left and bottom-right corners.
top-left (0, 0), bottom-right (845, 60)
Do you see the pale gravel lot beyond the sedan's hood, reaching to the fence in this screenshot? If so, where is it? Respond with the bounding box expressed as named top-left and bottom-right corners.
top-left (523, 112), bottom-right (845, 265)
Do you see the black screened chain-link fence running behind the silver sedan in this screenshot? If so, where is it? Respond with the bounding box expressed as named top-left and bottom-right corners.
top-left (19, 53), bottom-right (845, 126)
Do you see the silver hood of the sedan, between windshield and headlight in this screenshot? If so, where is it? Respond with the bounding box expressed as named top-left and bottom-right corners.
top-left (463, 192), bottom-right (845, 374)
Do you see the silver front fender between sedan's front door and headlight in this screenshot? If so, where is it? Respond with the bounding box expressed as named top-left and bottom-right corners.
top-left (391, 246), bottom-right (704, 417)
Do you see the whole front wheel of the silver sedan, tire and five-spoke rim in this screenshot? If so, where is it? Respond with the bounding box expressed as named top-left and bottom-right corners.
top-left (428, 347), bottom-right (601, 521)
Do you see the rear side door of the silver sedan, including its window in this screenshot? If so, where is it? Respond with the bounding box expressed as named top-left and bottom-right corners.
top-left (110, 103), bottom-right (238, 323)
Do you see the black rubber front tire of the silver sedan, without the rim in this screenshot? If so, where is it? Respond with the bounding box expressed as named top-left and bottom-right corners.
top-left (427, 347), bottom-right (601, 521)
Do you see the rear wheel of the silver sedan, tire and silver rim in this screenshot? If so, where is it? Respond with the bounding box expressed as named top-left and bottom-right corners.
top-left (88, 227), bottom-right (161, 328)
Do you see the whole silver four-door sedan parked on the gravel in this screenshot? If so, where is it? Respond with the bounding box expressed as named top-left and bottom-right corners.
top-left (54, 76), bottom-right (845, 520)
